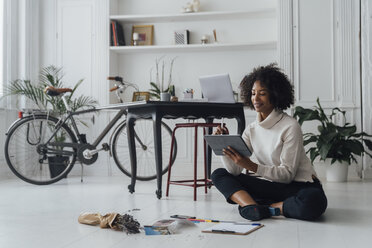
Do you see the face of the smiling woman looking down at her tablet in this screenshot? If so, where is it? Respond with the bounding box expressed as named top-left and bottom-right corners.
top-left (251, 81), bottom-right (274, 119)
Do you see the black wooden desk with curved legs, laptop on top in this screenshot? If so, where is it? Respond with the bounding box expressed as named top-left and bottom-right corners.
top-left (127, 101), bottom-right (245, 199)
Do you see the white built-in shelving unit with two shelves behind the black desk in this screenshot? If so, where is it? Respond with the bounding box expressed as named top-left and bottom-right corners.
top-left (108, 0), bottom-right (277, 104)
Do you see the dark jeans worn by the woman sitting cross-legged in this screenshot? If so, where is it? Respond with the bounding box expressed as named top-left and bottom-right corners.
top-left (212, 168), bottom-right (327, 220)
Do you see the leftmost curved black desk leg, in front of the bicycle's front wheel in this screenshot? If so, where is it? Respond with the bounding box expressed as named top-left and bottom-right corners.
top-left (127, 113), bottom-right (137, 193)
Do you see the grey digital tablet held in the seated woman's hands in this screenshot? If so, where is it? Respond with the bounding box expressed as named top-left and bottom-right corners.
top-left (204, 135), bottom-right (252, 157)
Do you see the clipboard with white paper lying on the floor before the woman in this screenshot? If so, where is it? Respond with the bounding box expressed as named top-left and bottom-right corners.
top-left (202, 223), bottom-right (264, 235)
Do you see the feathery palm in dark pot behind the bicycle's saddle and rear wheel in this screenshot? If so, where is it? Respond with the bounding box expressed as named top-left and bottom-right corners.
top-left (5, 66), bottom-right (97, 178)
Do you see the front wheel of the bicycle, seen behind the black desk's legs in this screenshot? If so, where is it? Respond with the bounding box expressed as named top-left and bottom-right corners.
top-left (112, 120), bottom-right (177, 181)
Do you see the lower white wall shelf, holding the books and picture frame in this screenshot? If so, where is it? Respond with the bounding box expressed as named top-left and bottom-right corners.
top-left (110, 41), bottom-right (277, 54)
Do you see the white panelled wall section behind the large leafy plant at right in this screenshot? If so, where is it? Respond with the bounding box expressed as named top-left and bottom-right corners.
top-left (293, 0), bottom-right (363, 178)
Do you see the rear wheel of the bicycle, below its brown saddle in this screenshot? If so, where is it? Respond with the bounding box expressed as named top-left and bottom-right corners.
top-left (5, 115), bottom-right (77, 185)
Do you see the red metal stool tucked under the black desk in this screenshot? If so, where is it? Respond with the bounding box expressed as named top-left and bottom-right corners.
top-left (166, 123), bottom-right (221, 201)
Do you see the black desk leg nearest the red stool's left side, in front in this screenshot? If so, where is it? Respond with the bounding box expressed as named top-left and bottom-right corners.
top-left (152, 115), bottom-right (163, 199)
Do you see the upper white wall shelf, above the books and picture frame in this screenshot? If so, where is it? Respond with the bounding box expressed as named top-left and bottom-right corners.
top-left (110, 8), bottom-right (276, 23)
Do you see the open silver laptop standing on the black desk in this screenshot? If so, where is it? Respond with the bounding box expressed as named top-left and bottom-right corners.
top-left (199, 74), bottom-right (235, 103)
